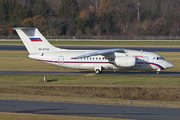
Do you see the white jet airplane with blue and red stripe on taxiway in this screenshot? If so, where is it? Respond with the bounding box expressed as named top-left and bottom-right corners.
top-left (10, 27), bottom-right (174, 74)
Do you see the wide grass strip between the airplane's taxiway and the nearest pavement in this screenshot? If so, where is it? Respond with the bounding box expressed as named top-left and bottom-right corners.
top-left (0, 75), bottom-right (180, 108)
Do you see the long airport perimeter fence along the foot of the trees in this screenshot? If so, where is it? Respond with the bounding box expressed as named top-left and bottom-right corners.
top-left (0, 35), bottom-right (180, 41)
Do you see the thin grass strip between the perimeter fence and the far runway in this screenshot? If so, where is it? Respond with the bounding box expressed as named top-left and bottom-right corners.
top-left (0, 41), bottom-right (180, 47)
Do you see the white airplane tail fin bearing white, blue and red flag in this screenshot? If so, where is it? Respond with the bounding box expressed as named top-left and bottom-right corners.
top-left (12, 27), bottom-right (60, 54)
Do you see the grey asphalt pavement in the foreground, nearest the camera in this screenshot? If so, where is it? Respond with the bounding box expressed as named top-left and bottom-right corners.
top-left (0, 100), bottom-right (180, 120)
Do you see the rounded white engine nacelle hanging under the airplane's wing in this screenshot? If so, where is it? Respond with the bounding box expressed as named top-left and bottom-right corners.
top-left (114, 56), bottom-right (136, 67)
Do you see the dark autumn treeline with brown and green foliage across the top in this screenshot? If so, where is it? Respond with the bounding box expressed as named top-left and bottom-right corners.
top-left (0, 0), bottom-right (180, 36)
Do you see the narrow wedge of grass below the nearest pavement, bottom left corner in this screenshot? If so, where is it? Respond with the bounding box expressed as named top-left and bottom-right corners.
top-left (0, 113), bottom-right (123, 120)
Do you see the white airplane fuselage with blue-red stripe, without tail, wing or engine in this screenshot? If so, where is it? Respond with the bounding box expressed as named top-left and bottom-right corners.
top-left (29, 49), bottom-right (173, 71)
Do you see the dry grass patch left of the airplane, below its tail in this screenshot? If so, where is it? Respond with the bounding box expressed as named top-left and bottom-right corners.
top-left (0, 51), bottom-right (72, 71)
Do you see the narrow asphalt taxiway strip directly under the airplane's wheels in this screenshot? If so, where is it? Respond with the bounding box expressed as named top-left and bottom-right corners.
top-left (0, 71), bottom-right (180, 77)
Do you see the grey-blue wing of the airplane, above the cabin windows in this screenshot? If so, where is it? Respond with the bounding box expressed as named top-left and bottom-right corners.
top-left (72, 49), bottom-right (124, 59)
